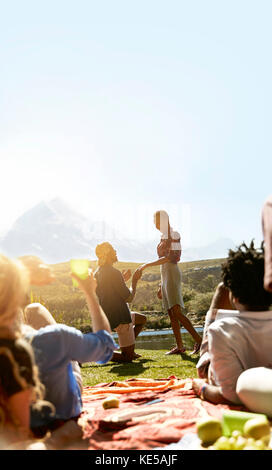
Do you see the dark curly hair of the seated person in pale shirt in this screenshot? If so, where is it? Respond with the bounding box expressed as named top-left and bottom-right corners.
top-left (222, 240), bottom-right (272, 310)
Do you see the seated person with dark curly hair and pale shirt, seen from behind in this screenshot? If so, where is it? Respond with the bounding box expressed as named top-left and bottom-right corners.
top-left (193, 241), bottom-right (272, 404)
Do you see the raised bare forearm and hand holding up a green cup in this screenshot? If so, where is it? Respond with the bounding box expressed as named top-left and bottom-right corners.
top-left (71, 271), bottom-right (111, 333)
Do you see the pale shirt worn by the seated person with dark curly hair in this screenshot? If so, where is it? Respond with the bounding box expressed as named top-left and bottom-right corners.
top-left (208, 311), bottom-right (272, 403)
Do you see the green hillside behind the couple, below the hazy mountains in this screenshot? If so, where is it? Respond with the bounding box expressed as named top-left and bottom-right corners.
top-left (31, 259), bottom-right (224, 331)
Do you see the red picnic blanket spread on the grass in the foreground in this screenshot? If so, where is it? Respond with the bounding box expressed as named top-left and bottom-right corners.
top-left (80, 376), bottom-right (244, 450)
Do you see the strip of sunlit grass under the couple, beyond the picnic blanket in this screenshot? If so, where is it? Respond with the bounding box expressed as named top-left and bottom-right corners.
top-left (81, 349), bottom-right (198, 386)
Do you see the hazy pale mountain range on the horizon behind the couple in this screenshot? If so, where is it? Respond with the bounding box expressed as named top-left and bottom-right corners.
top-left (0, 198), bottom-right (234, 263)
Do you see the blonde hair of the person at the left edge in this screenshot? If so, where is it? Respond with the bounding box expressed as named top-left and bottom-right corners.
top-left (0, 255), bottom-right (29, 335)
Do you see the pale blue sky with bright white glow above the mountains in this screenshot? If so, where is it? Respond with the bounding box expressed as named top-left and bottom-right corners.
top-left (0, 0), bottom-right (272, 246)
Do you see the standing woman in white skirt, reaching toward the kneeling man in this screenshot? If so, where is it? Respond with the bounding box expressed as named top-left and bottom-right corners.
top-left (138, 211), bottom-right (202, 354)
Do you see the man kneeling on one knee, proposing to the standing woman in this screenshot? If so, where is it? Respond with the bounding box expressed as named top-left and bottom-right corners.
top-left (95, 242), bottom-right (146, 362)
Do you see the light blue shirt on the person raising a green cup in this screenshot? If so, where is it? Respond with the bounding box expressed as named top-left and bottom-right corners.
top-left (27, 324), bottom-right (117, 427)
